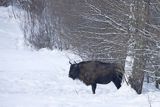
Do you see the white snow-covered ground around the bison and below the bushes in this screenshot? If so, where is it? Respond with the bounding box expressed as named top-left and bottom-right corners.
top-left (0, 7), bottom-right (160, 107)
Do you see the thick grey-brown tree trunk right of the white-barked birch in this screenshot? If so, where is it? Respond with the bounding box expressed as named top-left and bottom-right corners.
top-left (129, 0), bottom-right (148, 94)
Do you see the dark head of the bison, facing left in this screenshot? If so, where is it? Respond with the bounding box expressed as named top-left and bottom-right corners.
top-left (69, 64), bottom-right (79, 80)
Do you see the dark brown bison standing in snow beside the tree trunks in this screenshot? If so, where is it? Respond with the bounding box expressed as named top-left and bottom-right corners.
top-left (69, 61), bottom-right (124, 94)
